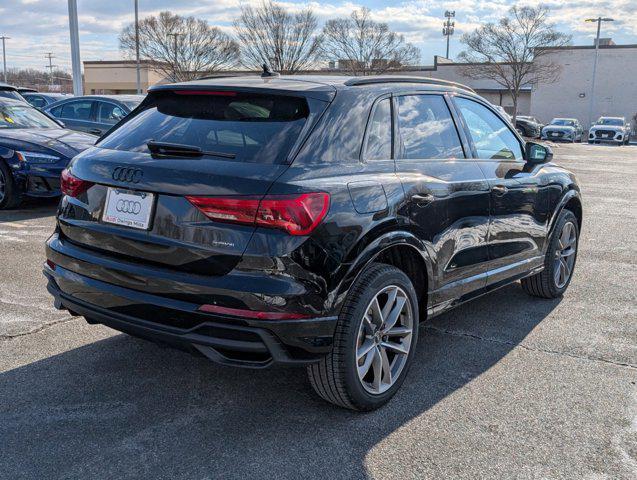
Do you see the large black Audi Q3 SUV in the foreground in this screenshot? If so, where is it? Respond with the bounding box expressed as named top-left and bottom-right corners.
top-left (44, 76), bottom-right (582, 410)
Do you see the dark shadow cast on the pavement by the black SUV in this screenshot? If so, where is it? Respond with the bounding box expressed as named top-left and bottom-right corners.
top-left (0, 285), bottom-right (559, 478)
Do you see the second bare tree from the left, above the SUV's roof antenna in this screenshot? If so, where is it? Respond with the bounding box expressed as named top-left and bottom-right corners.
top-left (234, 1), bottom-right (321, 74)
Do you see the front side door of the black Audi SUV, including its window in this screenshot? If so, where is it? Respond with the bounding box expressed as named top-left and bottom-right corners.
top-left (454, 96), bottom-right (549, 285)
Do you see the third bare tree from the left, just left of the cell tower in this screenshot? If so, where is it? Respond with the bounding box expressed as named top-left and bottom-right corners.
top-left (322, 8), bottom-right (420, 75)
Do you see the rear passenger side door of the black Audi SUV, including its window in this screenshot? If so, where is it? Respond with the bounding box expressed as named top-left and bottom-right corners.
top-left (395, 93), bottom-right (489, 310)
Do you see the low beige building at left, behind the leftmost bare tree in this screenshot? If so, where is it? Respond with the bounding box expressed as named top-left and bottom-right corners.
top-left (84, 61), bottom-right (164, 95)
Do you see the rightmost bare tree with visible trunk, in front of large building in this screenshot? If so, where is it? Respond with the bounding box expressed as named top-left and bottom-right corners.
top-left (459, 5), bottom-right (571, 122)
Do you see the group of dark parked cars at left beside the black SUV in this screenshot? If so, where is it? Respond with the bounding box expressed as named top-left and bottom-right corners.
top-left (0, 84), bottom-right (144, 209)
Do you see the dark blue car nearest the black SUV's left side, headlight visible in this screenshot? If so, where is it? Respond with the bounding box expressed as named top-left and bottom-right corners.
top-left (0, 98), bottom-right (97, 209)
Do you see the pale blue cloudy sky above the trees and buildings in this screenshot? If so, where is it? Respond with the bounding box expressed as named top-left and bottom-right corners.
top-left (0, 0), bottom-right (637, 70)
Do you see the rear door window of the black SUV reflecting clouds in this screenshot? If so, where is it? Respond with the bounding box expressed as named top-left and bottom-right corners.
top-left (398, 95), bottom-right (464, 159)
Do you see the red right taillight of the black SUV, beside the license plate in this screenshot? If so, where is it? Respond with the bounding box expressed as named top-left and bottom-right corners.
top-left (186, 192), bottom-right (330, 235)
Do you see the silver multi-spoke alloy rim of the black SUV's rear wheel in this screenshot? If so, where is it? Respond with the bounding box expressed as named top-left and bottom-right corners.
top-left (356, 285), bottom-right (414, 395)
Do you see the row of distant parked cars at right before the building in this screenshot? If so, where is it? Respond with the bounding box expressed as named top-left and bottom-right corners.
top-left (499, 107), bottom-right (631, 145)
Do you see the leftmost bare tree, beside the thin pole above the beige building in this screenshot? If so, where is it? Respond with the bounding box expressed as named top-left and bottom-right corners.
top-left (119, 12), bottom-right (239, 81)
